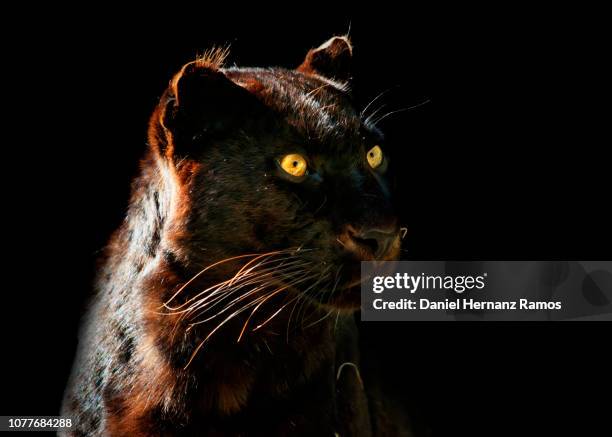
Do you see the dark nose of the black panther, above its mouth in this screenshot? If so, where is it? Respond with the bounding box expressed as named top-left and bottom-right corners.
top-left (343, 225), bottom-right (400, 260)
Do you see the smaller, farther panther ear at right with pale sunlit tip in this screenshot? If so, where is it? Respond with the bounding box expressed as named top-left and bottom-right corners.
top-left (297, 36), bottom-right (353, 81)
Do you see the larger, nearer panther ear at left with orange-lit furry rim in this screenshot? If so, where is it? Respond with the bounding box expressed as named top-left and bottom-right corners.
top-left (149, 50), bottom-right (261, 156)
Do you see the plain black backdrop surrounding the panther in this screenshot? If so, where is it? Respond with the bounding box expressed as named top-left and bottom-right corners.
top-left (0, 5), bottom-right (612, 436)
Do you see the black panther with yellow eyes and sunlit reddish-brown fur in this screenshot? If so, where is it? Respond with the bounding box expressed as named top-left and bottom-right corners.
top-left (62, 37), bottom-right (409, 437)
